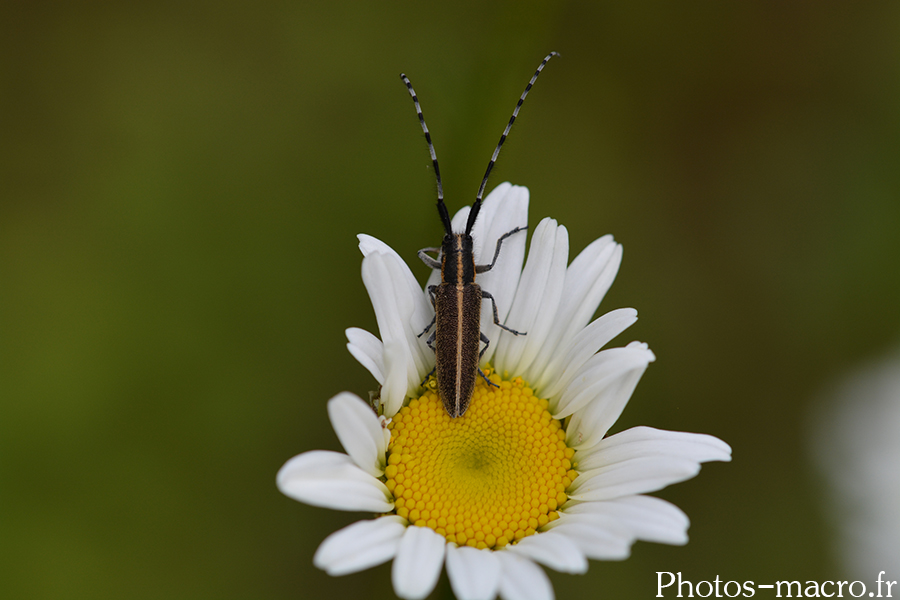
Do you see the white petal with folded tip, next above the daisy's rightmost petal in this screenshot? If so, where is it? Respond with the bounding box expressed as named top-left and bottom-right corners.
top-left (566, 342), bottom-right (655, 450)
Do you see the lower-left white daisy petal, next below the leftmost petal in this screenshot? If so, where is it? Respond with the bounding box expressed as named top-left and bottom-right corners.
top-left (313, 516), bottom-right (406, 577)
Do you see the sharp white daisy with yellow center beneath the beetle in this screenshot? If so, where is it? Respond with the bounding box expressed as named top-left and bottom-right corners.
top-left (277, 183), bottom-right (731, 600)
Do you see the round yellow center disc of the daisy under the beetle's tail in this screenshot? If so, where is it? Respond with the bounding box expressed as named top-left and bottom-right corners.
top-left (385, 375), bottom-right (577, 548)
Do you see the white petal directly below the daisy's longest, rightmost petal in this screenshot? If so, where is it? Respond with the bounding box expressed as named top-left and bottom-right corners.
top-left (568, 456), bottom-right (700, 501)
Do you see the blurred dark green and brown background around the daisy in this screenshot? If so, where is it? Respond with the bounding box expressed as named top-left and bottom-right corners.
top-left (0, 0), bottom-right (900, 599)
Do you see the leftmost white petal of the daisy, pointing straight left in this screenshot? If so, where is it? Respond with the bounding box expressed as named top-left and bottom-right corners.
top-left (276, 450), bottom-right (394, 512)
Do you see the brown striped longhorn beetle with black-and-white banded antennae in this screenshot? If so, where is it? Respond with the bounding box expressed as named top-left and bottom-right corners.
top-left (400, 52), bottom-right (557, 418)
